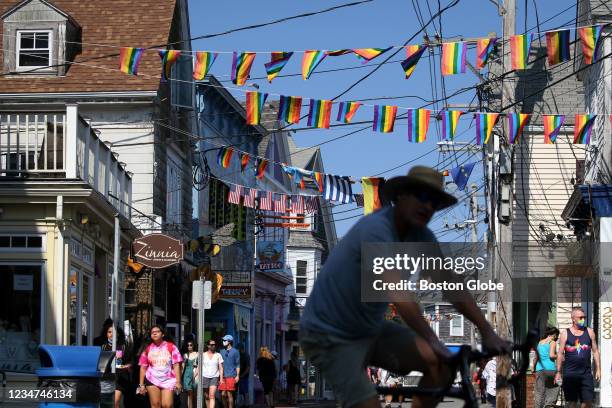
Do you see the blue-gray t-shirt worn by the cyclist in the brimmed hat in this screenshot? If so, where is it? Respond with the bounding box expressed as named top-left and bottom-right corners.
top-left (300, 207), bottom-right (437, 338)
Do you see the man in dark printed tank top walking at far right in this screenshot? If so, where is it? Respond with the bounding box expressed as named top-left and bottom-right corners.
top-left (555, 307), bottom-right (601, 408)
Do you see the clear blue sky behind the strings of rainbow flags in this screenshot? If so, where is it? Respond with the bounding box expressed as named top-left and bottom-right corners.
top-left (189, 0), bottom-right (576, 241)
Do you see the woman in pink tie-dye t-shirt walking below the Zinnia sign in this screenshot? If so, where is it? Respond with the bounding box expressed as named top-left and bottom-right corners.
top-left (137, 325), bottom-right (183, 408)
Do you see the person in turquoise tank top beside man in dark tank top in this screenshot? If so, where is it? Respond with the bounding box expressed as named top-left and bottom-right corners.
top-left (534, 327), bottom-right (559, 408)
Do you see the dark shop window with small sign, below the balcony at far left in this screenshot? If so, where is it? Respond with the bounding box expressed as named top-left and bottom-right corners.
top-left (0, 264), bottom-right (43, 373)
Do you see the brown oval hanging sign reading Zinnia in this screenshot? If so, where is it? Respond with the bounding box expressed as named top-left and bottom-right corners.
top-left (132, 234), bottom-right (183, 269)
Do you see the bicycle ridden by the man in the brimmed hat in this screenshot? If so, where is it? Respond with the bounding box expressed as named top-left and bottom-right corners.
top-left (376, 330), bottom-right (539, 408)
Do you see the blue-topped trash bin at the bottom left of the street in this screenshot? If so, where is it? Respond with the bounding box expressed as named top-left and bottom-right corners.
top-left (36, 344), bottom-right (113, 408)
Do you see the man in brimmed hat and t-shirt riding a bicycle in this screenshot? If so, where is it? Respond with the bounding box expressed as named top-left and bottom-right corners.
top-left (300, 166), bottom-right (508, 408)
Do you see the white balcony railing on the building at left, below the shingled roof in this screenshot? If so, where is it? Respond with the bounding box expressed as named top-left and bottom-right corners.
top-left (0, 105), bottom-right (132, 219)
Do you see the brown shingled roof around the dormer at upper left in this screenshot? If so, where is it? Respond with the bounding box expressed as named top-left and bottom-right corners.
top-left (0, 0), bottom-right (179, 94)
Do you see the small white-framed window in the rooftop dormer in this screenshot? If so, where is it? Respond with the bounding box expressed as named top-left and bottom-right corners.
top-left (16, 30), bottom-right (53, 69)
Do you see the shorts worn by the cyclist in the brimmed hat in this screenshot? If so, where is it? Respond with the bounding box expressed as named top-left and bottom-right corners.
top-left (300, 322), bottom-right (416, 407)
